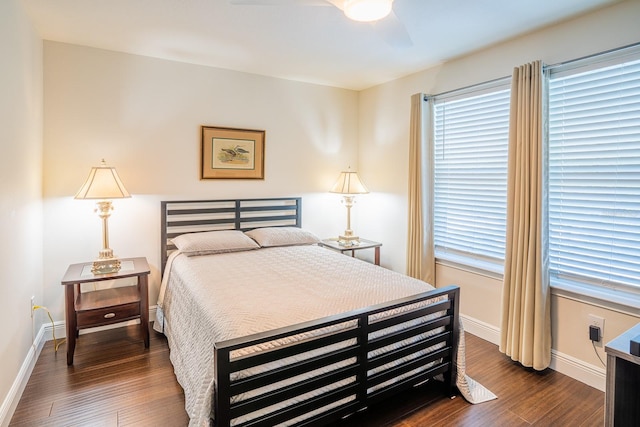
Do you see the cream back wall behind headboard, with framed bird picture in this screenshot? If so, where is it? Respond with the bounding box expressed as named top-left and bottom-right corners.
top-left (44, 41), bottom-right (358, 320)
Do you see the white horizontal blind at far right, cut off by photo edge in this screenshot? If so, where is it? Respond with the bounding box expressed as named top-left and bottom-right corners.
top-left (549, 57), bottom-right (640, 290)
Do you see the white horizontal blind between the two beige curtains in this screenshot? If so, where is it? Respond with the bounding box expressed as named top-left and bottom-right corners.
top-left (433, 88), bottom-right (510, 271)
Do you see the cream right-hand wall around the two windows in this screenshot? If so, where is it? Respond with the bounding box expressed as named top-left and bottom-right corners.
top-left (359, 1), bottom-right (640, 386)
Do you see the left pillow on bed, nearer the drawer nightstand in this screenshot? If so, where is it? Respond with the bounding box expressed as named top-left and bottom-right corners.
top-left (172, 230), bottom-right (260, 256)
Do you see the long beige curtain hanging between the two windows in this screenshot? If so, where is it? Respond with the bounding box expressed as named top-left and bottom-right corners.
top-left (500, 61), bottom-right (551, 370)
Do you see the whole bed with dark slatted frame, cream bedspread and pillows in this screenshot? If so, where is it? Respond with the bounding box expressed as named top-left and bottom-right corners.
top-left (154, 197), bottom-right (460, 427)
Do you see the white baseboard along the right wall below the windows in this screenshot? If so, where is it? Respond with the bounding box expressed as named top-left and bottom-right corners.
top-left (460, 315), bottom-right (606, 391)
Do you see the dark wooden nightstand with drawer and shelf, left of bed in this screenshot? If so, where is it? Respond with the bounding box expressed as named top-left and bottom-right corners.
top-left (62, 258), bottom-right (149, 365)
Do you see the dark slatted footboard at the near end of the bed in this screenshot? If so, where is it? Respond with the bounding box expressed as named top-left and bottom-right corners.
top-left (214, 286), bottom-right (459, 427)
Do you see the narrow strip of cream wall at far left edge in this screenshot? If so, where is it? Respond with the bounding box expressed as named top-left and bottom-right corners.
top-left (0, 0), bottom-right (42, 424)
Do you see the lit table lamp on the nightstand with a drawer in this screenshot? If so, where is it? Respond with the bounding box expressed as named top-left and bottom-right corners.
top-left (74, 159), bottom-right (131, 274)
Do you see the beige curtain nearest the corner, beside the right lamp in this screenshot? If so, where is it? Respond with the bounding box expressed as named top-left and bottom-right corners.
top-left (407, 93), bottom-right (436, 286)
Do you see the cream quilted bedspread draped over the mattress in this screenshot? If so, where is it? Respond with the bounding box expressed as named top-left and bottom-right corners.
top-left (155, 245), bottom-right (444, 426)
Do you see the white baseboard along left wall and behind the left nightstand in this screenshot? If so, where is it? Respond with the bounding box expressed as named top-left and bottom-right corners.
top-left (0, 305), bottom-right (156, 427)
